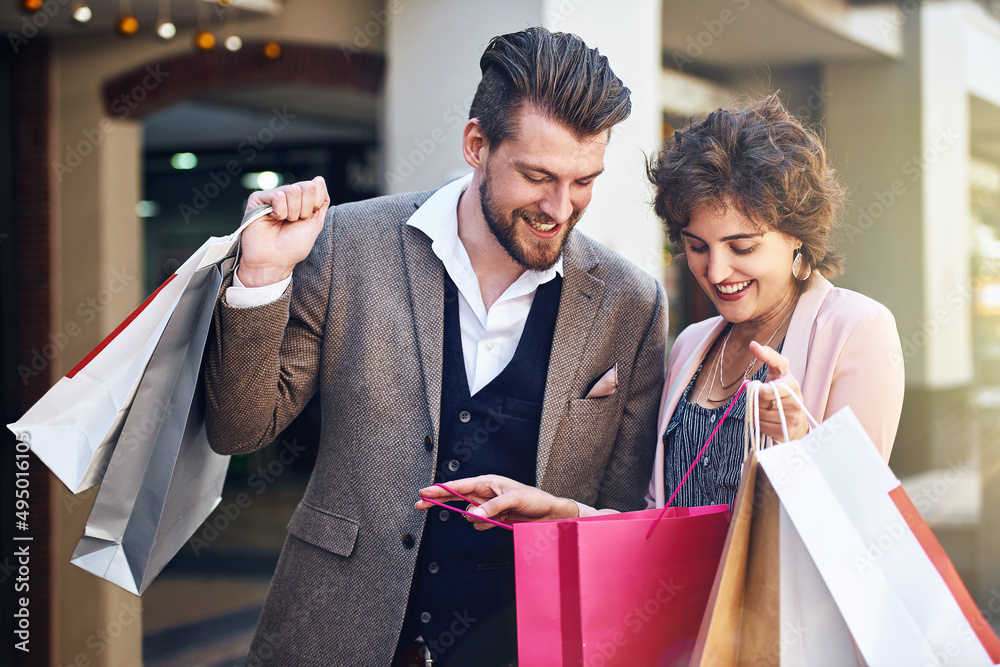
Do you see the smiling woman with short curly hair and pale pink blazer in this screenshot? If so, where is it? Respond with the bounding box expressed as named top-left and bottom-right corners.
top-left (417, 95), bottom-right (903, 530)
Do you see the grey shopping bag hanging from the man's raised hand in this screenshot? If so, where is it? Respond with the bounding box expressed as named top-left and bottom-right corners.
top-left (71, 259), bottom-right (233, 595)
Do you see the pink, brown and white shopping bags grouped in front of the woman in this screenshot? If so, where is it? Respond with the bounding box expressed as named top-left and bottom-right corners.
top-left (514, 383), bottom-right (1000, 667)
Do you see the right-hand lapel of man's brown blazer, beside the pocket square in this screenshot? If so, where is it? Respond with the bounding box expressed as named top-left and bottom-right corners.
top-left (535, 233), bottom-right (604, 485)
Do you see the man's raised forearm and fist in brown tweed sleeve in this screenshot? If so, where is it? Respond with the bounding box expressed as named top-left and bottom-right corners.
top-left (205, 176), bottom-right (331, 454)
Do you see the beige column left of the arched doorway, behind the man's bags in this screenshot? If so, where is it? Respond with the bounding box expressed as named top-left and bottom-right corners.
top-left (51, 41), bottom-right (142, 667)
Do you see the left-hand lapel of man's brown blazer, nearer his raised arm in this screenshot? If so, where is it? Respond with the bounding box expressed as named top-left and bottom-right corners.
top-left (402, 201), bottom-right (444, 442)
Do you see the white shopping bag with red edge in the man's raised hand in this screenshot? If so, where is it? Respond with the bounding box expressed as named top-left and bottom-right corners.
top-left (7, 205), bottom-right (271, 493)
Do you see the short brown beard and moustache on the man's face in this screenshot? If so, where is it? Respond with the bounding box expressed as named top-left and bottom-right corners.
top-left (479, 167), bottom-right (583, 271)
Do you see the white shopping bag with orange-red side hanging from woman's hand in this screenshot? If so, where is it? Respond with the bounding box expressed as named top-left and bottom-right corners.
top-left (747, 385), bottom-right (1000, 667)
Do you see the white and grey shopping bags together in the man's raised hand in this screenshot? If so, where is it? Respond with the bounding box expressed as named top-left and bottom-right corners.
top-left (8, 206), bottom-right (271, 595)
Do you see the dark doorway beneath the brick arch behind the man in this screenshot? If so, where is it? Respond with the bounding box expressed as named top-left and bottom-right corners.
top-left (102, 43), bottom-right (383, 666)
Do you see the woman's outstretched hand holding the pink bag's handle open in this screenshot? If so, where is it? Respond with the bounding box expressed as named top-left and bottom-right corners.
top-left (415, 475), bottom-right (579, 530)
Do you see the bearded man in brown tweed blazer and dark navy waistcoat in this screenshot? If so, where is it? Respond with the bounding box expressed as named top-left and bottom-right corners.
top-left (206, 28), bottom-right (666, 667)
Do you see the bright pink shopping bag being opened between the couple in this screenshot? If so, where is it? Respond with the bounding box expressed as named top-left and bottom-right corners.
top-left (514, 505), bottom-right (729, 667)
